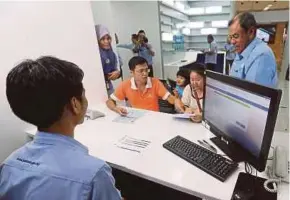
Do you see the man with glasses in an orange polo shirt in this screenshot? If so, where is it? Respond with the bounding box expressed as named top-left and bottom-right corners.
top-left (107, 56), bottom-right (182, 115)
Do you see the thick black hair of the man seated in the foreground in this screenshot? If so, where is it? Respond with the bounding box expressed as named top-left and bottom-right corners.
top-left (6, 56), bottom-right (84, 129)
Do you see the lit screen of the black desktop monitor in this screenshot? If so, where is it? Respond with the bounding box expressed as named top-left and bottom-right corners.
top-left (204, 77), bottom-right (270, 157)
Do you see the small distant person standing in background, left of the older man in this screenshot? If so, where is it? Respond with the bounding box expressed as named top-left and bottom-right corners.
top-left (202, 34), bottom-right (218, 71)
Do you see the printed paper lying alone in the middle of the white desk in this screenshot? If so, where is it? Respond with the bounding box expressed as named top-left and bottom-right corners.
top-left (115, 135), bottom-right (151, 153)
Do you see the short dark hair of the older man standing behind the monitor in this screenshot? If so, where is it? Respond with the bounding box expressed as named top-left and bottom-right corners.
top-left (228, 12), bottom-right (257, 31)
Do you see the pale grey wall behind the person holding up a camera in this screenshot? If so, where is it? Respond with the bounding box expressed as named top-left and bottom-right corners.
top-left (111, 1), bottom-right (162, 77)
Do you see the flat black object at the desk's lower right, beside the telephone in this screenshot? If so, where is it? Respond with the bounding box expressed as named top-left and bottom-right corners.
top-left (231, 172), bottom-right (277, 200)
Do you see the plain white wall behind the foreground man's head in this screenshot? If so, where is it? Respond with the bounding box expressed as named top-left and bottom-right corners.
top-left (0, 2), bottom-right (106, 162)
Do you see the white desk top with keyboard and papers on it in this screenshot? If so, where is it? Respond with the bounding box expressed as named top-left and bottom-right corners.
top-left (27, 104), bottom-right (289, 200)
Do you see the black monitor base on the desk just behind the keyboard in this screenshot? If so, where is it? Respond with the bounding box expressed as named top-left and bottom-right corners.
top-left (210, 137), bottom-right (247, 162)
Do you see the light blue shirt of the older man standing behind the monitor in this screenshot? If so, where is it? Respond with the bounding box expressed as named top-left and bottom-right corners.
top-left (230, 38), bottom-right (277, 87)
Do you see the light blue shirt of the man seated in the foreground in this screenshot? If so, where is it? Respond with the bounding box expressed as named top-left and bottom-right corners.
top-left (0, 132), bottom-right (121, 200)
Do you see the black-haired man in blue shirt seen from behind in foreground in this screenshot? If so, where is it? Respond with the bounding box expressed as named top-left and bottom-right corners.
top-left (0, 57), bottom-right (121, 200)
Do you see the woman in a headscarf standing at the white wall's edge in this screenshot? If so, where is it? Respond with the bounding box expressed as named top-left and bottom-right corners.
top-left (95, 24), bottom-right (120, 95)
